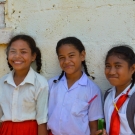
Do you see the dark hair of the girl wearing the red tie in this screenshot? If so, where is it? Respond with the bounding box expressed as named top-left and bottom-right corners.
top-left (105, 45), bottom-right (135, 89)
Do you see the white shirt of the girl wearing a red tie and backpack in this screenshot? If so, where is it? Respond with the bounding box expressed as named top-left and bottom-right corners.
top-left (104, 85), bottom-right (135, 135)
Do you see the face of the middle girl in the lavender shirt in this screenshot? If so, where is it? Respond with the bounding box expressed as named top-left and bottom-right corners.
top-left (58, 44), bottom-right (85, 75)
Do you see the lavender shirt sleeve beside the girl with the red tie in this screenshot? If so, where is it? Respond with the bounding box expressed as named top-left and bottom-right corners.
top-left (88, 87), bottom-right (104, 121)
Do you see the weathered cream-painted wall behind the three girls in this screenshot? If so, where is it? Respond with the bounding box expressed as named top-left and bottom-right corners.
top-left (0, 0), bottom-right (135, 90)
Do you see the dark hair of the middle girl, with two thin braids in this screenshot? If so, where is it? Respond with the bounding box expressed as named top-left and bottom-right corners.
top-left (54, 37), bottom-right (94, 83)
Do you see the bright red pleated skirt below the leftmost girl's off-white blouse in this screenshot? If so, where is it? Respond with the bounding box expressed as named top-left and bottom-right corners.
top-left (0, 120), bottom-right (38, 135)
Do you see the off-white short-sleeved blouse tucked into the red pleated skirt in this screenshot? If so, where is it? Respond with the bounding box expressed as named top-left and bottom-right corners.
top-left (0, 68), bottom-right (48, 124)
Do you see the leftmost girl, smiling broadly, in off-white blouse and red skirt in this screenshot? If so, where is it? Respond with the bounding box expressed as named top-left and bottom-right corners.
top-left (0, 35), bottom-right (48, 135)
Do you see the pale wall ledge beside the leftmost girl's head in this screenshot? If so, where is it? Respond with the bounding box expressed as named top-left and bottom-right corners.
top-left (0, 28), bottom-right (13, 44)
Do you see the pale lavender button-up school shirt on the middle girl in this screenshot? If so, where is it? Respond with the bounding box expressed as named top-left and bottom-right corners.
top-left (48, 73), bottom-right (103, 135)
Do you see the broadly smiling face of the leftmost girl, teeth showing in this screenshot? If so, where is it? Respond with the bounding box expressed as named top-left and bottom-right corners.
top-left (8, 40), bottom-right (36, 71)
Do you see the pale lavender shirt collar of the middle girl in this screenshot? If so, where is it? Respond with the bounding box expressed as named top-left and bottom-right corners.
top-left (61, 72), bottom-right (88, 85)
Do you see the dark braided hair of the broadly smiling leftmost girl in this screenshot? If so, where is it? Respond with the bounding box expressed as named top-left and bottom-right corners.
top-left (6, 35), bottom-right (42, 73)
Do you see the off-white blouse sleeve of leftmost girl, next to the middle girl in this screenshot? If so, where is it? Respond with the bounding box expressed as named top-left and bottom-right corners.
top-left (36, 86), bottom-right (48, 125)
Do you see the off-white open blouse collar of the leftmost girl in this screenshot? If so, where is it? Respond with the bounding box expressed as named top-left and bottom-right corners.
top-left (4, 67), bottom-right (35, 86)
